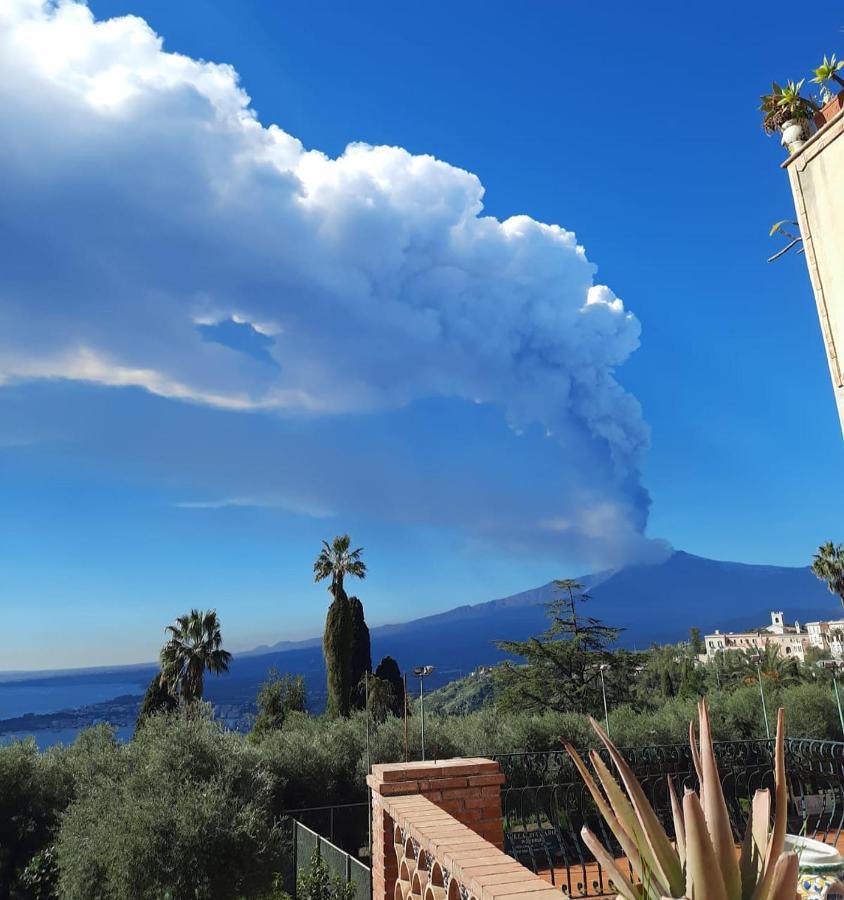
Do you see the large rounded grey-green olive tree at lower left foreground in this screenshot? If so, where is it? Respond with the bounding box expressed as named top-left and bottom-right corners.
top-left (57, 704), bottom-right (282, 900)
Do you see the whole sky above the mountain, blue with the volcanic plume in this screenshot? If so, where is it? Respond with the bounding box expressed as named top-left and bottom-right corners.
top-left (0, 0), bottom-right (844, 669)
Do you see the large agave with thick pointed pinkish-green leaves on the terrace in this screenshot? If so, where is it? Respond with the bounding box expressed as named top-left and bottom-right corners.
top-left (566, 701), bottom-right (798, 900)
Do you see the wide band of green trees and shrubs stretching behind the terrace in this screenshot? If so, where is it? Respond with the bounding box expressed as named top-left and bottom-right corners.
top-left (0, 668), bottom-right (842, 900)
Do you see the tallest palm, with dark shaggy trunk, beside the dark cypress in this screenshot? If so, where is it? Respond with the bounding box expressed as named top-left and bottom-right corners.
top-left (314, 534), bottom-right (366, 717)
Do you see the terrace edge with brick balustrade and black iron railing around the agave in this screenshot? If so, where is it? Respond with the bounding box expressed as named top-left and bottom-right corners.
top-left (368, 739), bottom-right (844, 900)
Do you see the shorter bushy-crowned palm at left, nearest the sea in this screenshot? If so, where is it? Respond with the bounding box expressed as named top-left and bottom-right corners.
top-left (161, 609), bottom-right (232, 703)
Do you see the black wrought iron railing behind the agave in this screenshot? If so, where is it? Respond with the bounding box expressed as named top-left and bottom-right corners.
top-left (493, 740), bottom-right (844, 897)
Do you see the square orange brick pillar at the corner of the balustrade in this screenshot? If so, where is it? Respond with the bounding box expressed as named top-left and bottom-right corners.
top-left (366, 758), bottom-right (504, 900)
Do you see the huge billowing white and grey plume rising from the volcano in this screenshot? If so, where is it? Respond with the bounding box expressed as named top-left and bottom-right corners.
top-left (0, 0), bottom-right (660, 564)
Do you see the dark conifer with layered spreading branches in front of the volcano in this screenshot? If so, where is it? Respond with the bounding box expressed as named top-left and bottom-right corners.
top-left (495, 580), bottom-right (619, 712)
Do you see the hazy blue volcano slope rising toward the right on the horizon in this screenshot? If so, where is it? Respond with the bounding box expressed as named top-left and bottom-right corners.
top-left (3, 551), bottom-right (841, 709)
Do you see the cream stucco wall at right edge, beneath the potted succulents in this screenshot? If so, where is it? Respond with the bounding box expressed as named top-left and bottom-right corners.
top-left (785, 113), bottom-right (844, 431)
